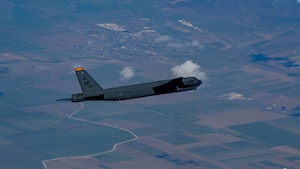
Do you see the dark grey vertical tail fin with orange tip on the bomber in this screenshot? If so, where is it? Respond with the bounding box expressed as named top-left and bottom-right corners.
top-left (74, 67), bottom-right (103, 93)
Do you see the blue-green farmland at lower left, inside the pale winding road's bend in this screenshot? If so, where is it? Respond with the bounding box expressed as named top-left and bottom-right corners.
top-left (0, 104), bottom-right (133, 168)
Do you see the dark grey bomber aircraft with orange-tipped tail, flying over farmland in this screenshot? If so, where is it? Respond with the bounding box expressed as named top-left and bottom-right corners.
top-left (72, 67), bottom-right (202, 102)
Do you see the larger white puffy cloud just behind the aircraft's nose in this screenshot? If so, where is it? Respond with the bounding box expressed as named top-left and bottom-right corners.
top-left (171, 60), bottom-right (208, 80)
